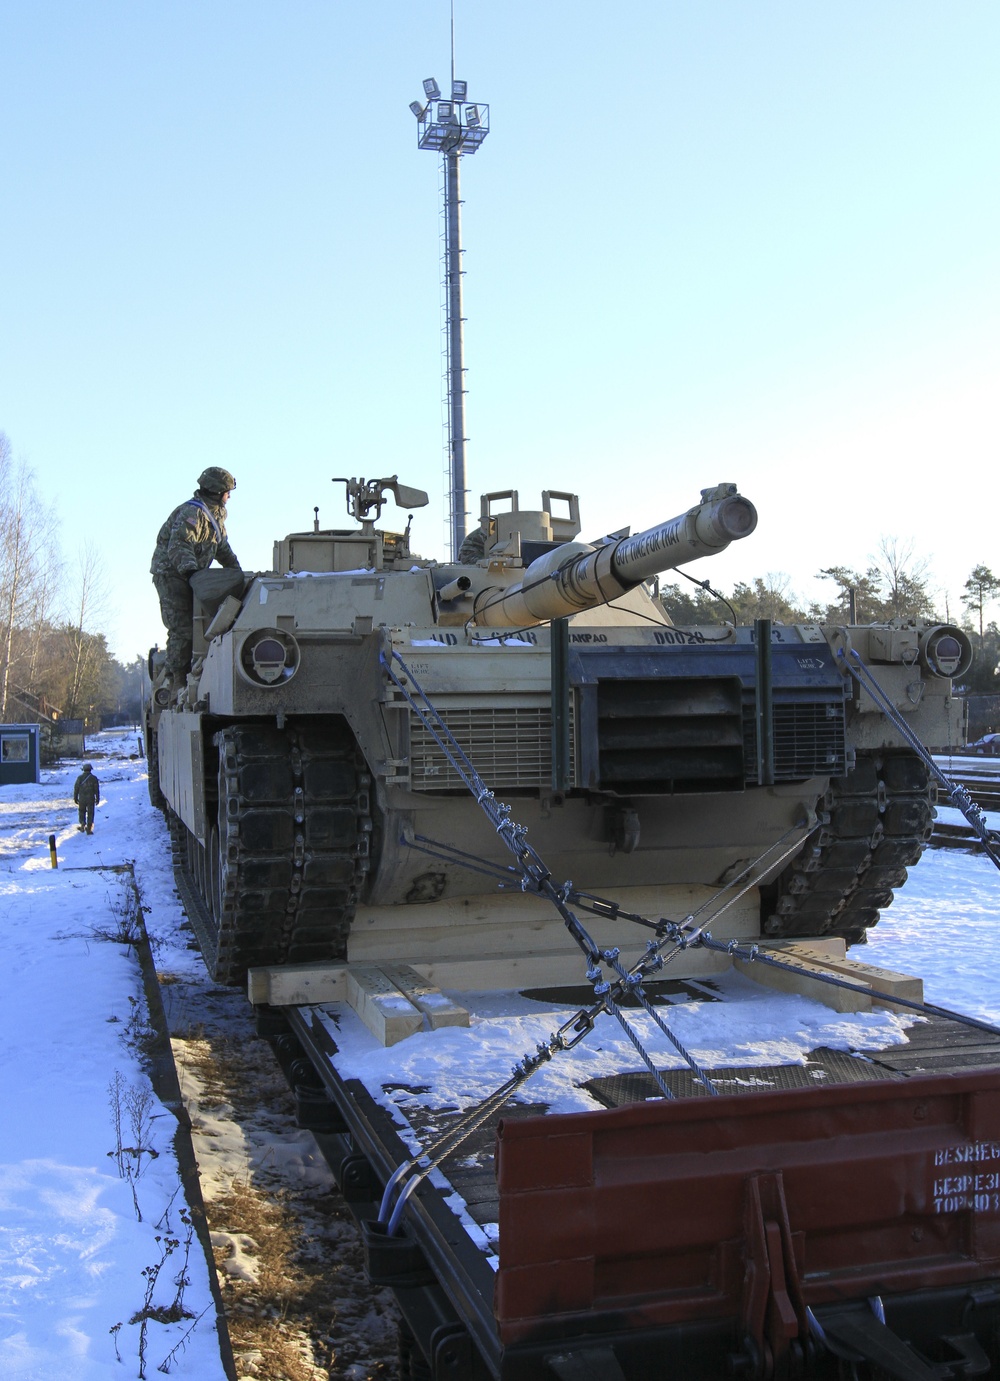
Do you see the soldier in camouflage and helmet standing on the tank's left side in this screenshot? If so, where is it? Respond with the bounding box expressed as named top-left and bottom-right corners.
top-left (149, 465), bottom-right (240, 686)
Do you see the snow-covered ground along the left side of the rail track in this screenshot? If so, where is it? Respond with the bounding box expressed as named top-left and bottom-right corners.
top-left (0, 735), bottom-right (225, 1381)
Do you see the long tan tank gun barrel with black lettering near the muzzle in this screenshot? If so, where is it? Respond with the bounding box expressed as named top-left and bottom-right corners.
top-left (472, 485), bottom-right (757, 628)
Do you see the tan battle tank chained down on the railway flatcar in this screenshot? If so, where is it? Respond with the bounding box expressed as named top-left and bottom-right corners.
top-left (146, 476), bottom-right (971, 987)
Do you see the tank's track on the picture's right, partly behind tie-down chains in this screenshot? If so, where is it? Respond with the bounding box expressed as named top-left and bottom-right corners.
top-left (761, 750), bottom-right (936, 945)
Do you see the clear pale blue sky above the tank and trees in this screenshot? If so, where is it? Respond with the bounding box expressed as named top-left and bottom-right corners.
top-left (0, 0), bottom-right (1000, 659)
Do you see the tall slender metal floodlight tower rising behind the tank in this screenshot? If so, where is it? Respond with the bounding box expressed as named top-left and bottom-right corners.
top-left (410, 74), bottom-right (489, 561)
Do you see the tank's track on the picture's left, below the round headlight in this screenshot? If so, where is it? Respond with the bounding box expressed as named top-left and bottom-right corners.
top-left (173, 721), bottom-right (372, 983)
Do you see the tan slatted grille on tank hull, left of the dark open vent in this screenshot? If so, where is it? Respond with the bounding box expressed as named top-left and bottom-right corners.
top-left (410, 706), bottom-right (575, 791)
